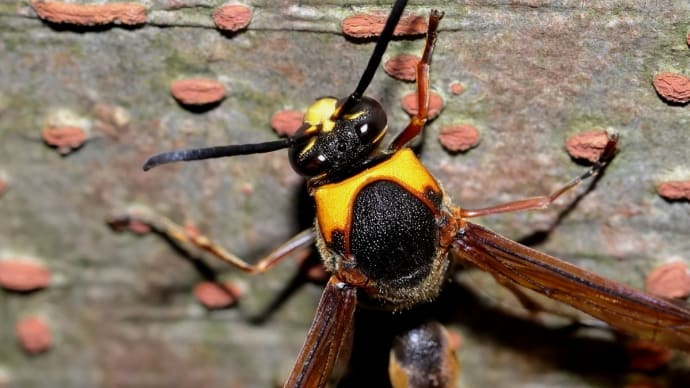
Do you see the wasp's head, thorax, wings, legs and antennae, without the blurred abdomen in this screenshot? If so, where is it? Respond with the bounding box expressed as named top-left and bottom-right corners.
top-left (115, 0), bottom-right (690, 388)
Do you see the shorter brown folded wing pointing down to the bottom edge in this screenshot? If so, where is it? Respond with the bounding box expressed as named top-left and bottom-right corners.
top-left (284, 276), bottom-right (357, 388)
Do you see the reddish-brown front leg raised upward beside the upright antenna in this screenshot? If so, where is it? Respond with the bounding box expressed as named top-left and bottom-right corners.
top-left (389, 10), bottom-right (443, 152)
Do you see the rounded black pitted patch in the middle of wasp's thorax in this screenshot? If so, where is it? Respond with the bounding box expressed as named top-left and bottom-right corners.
top-left (350, 181), bottom-right (438, 287)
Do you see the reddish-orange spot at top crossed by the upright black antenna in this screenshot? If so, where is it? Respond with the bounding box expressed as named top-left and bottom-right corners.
top-left (341, 13), bottom-right (429, 39)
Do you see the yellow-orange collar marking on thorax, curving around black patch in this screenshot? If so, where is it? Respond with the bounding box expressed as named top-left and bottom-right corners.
top-left (314, 148), bottom-right (441, 243)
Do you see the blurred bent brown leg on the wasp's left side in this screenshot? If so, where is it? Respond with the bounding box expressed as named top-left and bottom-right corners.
top-left (107, 208), bottom-right (316, 274)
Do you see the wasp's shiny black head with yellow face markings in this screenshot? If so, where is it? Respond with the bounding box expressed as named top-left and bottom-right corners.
top-left (290, 97), bottom-right (387, 177)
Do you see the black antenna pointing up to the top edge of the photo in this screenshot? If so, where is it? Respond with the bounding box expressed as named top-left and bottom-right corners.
top-left (335, 0), bottom-right (407, 118)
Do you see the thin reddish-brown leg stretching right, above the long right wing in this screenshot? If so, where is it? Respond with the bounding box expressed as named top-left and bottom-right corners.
top-left (459, 133), bottom-right (618, 218)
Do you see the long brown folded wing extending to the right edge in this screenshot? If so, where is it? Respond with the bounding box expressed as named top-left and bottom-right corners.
top-left (454, 222), bottom-right (690, 351)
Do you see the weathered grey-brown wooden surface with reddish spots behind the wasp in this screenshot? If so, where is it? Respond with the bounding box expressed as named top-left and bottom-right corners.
top-left (0, 0), bottom-right (690, 387)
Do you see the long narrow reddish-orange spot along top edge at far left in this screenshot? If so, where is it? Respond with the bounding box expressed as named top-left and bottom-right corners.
top-left (31, 0), bottom-right (146, 26)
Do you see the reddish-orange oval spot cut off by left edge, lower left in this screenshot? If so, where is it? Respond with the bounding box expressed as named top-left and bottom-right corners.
top-left (0, 260), bottom-right (50, 292)
